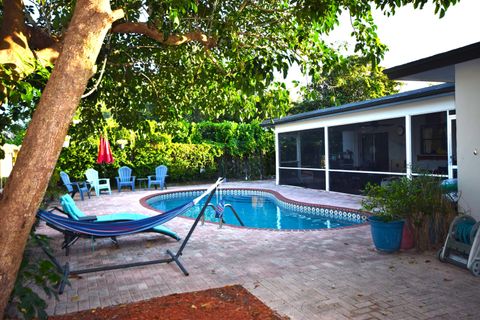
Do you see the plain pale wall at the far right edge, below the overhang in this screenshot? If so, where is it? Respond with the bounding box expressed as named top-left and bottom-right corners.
top-left (455, 59), bottom-right (480, 220)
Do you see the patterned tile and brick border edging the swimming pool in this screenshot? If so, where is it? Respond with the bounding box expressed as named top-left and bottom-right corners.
top-left (140, 188), bottom-right (371, 232)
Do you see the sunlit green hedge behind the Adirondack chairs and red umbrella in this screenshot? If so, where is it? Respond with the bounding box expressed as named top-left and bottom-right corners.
top-left (57, 121), bottom-right (275, 181)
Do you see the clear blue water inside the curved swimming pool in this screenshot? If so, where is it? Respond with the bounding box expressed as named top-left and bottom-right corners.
top-left (147, 190), bottom-right (365, 230)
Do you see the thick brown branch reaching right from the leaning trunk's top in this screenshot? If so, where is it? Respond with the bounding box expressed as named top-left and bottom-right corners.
top-left (111, 22), bottom-right (217, 49)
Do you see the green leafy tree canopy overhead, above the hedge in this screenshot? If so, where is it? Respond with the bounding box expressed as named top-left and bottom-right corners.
top-left (0, 0), bottom-right (455, 135)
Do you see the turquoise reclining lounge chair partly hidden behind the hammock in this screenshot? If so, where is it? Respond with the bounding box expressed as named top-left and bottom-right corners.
top-left (60, 194), bottom-right (181, 248)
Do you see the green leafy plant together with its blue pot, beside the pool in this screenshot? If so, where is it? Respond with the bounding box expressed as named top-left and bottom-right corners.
top-left (362, 177), bottom-right (413, 252)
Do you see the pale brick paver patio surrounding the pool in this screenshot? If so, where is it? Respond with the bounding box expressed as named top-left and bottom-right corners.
top-left (39, 182), bottom-right (480, 319)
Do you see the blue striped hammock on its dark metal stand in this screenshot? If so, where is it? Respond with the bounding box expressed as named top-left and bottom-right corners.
top-left (37, 179), bottom-right (223, 293)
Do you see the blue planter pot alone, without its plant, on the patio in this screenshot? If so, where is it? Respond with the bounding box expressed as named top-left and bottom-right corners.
top-left (368, 216), bottom-right (404, 252)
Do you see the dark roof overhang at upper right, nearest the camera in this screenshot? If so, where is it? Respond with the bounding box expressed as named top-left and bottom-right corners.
top-left (383, 42), bottom-right (480, 82)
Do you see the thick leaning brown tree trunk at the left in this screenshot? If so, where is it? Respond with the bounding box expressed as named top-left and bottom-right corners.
top-left (0, 0), bottom-right (123, 319)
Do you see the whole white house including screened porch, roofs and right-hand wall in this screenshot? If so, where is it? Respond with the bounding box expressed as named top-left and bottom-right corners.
top-left (265, 43), bottom-right (480, 218)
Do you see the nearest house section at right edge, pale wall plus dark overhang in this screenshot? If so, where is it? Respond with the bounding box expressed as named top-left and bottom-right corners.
top-left (385, 42), bottom-right (480, 220)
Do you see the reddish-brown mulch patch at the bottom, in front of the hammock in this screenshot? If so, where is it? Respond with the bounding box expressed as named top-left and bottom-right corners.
top-left (49, 285), bottom-right (289, 320)
